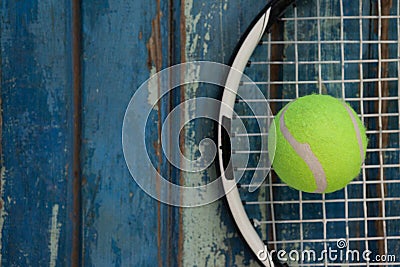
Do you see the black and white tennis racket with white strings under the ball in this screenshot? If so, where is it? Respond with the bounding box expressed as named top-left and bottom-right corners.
top-left (218, 0), bottom-right (400, 266)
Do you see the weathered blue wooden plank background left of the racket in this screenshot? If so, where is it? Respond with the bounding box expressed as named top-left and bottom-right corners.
top-left (0, 0), bottom-right (398, 266)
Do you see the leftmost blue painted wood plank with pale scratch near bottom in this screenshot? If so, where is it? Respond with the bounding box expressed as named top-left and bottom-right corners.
top-left (0, 0), bottom-right (72, 266)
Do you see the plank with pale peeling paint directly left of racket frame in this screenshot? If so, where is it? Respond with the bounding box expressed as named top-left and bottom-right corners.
top-left (181, 0), bottom-right (272, 266)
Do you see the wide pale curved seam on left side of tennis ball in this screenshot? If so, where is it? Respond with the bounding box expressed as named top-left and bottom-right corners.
top-left (279, 105), bottom-right (328, 193)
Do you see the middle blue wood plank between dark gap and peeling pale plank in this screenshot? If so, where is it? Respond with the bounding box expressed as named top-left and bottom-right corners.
top-left (82, 0), bottom-right (178, 266)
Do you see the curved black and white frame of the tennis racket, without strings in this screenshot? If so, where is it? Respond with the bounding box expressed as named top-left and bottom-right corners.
top-left (218, 0), bottom-right (295, 267)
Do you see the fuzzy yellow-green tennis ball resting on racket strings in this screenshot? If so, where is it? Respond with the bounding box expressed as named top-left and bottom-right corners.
top-left (268, 94), bottom-right (368, 193)
